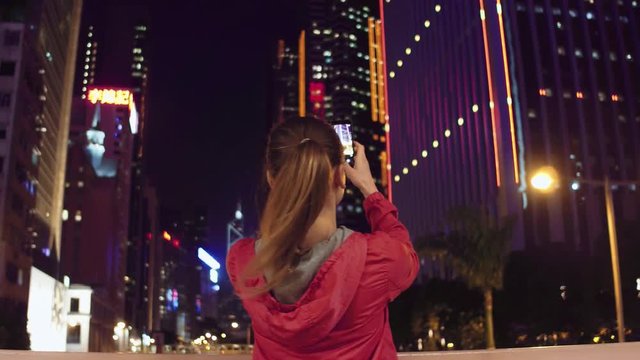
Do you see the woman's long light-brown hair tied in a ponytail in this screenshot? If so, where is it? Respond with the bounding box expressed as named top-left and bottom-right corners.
top-left (241, 118), bottom-right (343, 296)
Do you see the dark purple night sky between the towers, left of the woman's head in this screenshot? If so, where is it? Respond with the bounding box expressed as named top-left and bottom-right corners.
top-left (146, 0), bottom-right (300, 246)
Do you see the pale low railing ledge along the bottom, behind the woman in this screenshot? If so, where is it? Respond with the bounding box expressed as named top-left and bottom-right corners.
top-left (0, 342), bottom-right (640, 360)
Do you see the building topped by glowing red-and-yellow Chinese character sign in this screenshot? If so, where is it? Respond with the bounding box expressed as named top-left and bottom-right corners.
top-left (62, 87), bottom-right (138, 351)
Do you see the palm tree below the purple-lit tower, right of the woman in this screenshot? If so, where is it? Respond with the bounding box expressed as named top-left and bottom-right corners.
top-left (416, 207), bottom-right (514, 349)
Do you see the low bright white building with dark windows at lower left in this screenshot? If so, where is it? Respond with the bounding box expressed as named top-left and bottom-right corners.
top-left (67, 284), bottom-right (93, 352)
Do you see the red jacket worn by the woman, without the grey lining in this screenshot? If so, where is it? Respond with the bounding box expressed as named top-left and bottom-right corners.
top-left (227, 193), bottom-right (419, 360)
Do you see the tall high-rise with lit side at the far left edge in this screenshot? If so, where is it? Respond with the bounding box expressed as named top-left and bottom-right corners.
top-left (0, 0), bottom-right (82, 348)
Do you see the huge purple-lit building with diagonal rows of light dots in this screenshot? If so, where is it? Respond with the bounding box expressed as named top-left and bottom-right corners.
top-left (381, 0), bottom-right (640, 253)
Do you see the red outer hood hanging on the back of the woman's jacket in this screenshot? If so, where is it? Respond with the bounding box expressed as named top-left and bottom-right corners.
top-left (229, 233), bottom-right (367, 347)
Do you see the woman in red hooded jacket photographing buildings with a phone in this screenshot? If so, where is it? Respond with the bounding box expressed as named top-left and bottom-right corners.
top-left (227, 118), bottom-right (419, 360)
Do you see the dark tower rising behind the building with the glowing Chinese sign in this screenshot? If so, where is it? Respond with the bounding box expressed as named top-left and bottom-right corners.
top-left (70, 0), bottom-right (154, 340)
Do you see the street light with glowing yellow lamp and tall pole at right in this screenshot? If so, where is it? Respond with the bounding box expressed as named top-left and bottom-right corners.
top-left (531, 166), bottom-right (640, 342)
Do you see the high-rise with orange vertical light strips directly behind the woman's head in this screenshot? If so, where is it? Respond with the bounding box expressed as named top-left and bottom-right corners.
top-left (275, 0), bottom-right (389, 230)
